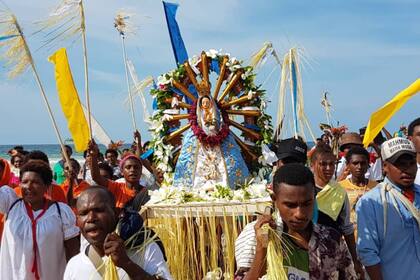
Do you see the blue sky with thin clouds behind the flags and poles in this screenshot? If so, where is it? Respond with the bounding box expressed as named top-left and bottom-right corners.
top-left (0, 0), bottom-right (420, 144)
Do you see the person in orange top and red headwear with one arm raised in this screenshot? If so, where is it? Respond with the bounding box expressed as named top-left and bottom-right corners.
top-left (88, 140), bottom-right (150, 211)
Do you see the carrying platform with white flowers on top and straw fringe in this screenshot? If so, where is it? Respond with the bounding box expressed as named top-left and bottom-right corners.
top-left (142, 183), bottom-right (272, 279)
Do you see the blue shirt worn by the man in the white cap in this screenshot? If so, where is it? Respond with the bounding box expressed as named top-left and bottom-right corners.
top-left (356, 179), bottom-right (420, 280)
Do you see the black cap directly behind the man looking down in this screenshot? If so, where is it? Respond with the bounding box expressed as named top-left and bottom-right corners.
top-left (275, 138), bottom-right (308, 162)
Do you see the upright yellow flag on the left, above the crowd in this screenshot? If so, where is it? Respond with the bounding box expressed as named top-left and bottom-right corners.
top-left (48, 48), bottom-right (89, 152)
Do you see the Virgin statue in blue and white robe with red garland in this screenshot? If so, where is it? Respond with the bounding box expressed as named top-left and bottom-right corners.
top-left (174, 95), bottom-right (249, 189)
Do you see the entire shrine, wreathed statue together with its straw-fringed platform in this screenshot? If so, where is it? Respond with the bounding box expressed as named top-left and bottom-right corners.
top-left (142, 47), bottom-right (273, 279)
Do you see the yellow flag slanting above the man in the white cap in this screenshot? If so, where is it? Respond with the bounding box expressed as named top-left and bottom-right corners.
top-left (363, 79), bottom-right (420, 147)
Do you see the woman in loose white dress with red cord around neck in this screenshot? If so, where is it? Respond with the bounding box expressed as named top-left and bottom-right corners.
top-left (0, 160), bottom-right (80, 280)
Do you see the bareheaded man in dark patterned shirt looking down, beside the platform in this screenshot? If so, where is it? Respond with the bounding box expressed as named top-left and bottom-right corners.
top-left (235, 163), bottom-right (357, 280)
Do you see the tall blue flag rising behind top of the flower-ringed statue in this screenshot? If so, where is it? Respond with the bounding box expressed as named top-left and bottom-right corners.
top-left (162, 1), bottom-right (188, 65)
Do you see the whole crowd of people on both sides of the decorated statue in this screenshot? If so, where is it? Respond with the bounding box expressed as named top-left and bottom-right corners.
top-left (0, 118), bottom-right (420, 280)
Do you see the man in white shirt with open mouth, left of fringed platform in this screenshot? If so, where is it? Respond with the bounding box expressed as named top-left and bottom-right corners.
top-left (64, 187), bottom-right (172, 280)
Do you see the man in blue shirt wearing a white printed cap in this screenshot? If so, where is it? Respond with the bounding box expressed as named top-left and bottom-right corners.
top-left (356, 137), bottom-right (420, 280)
